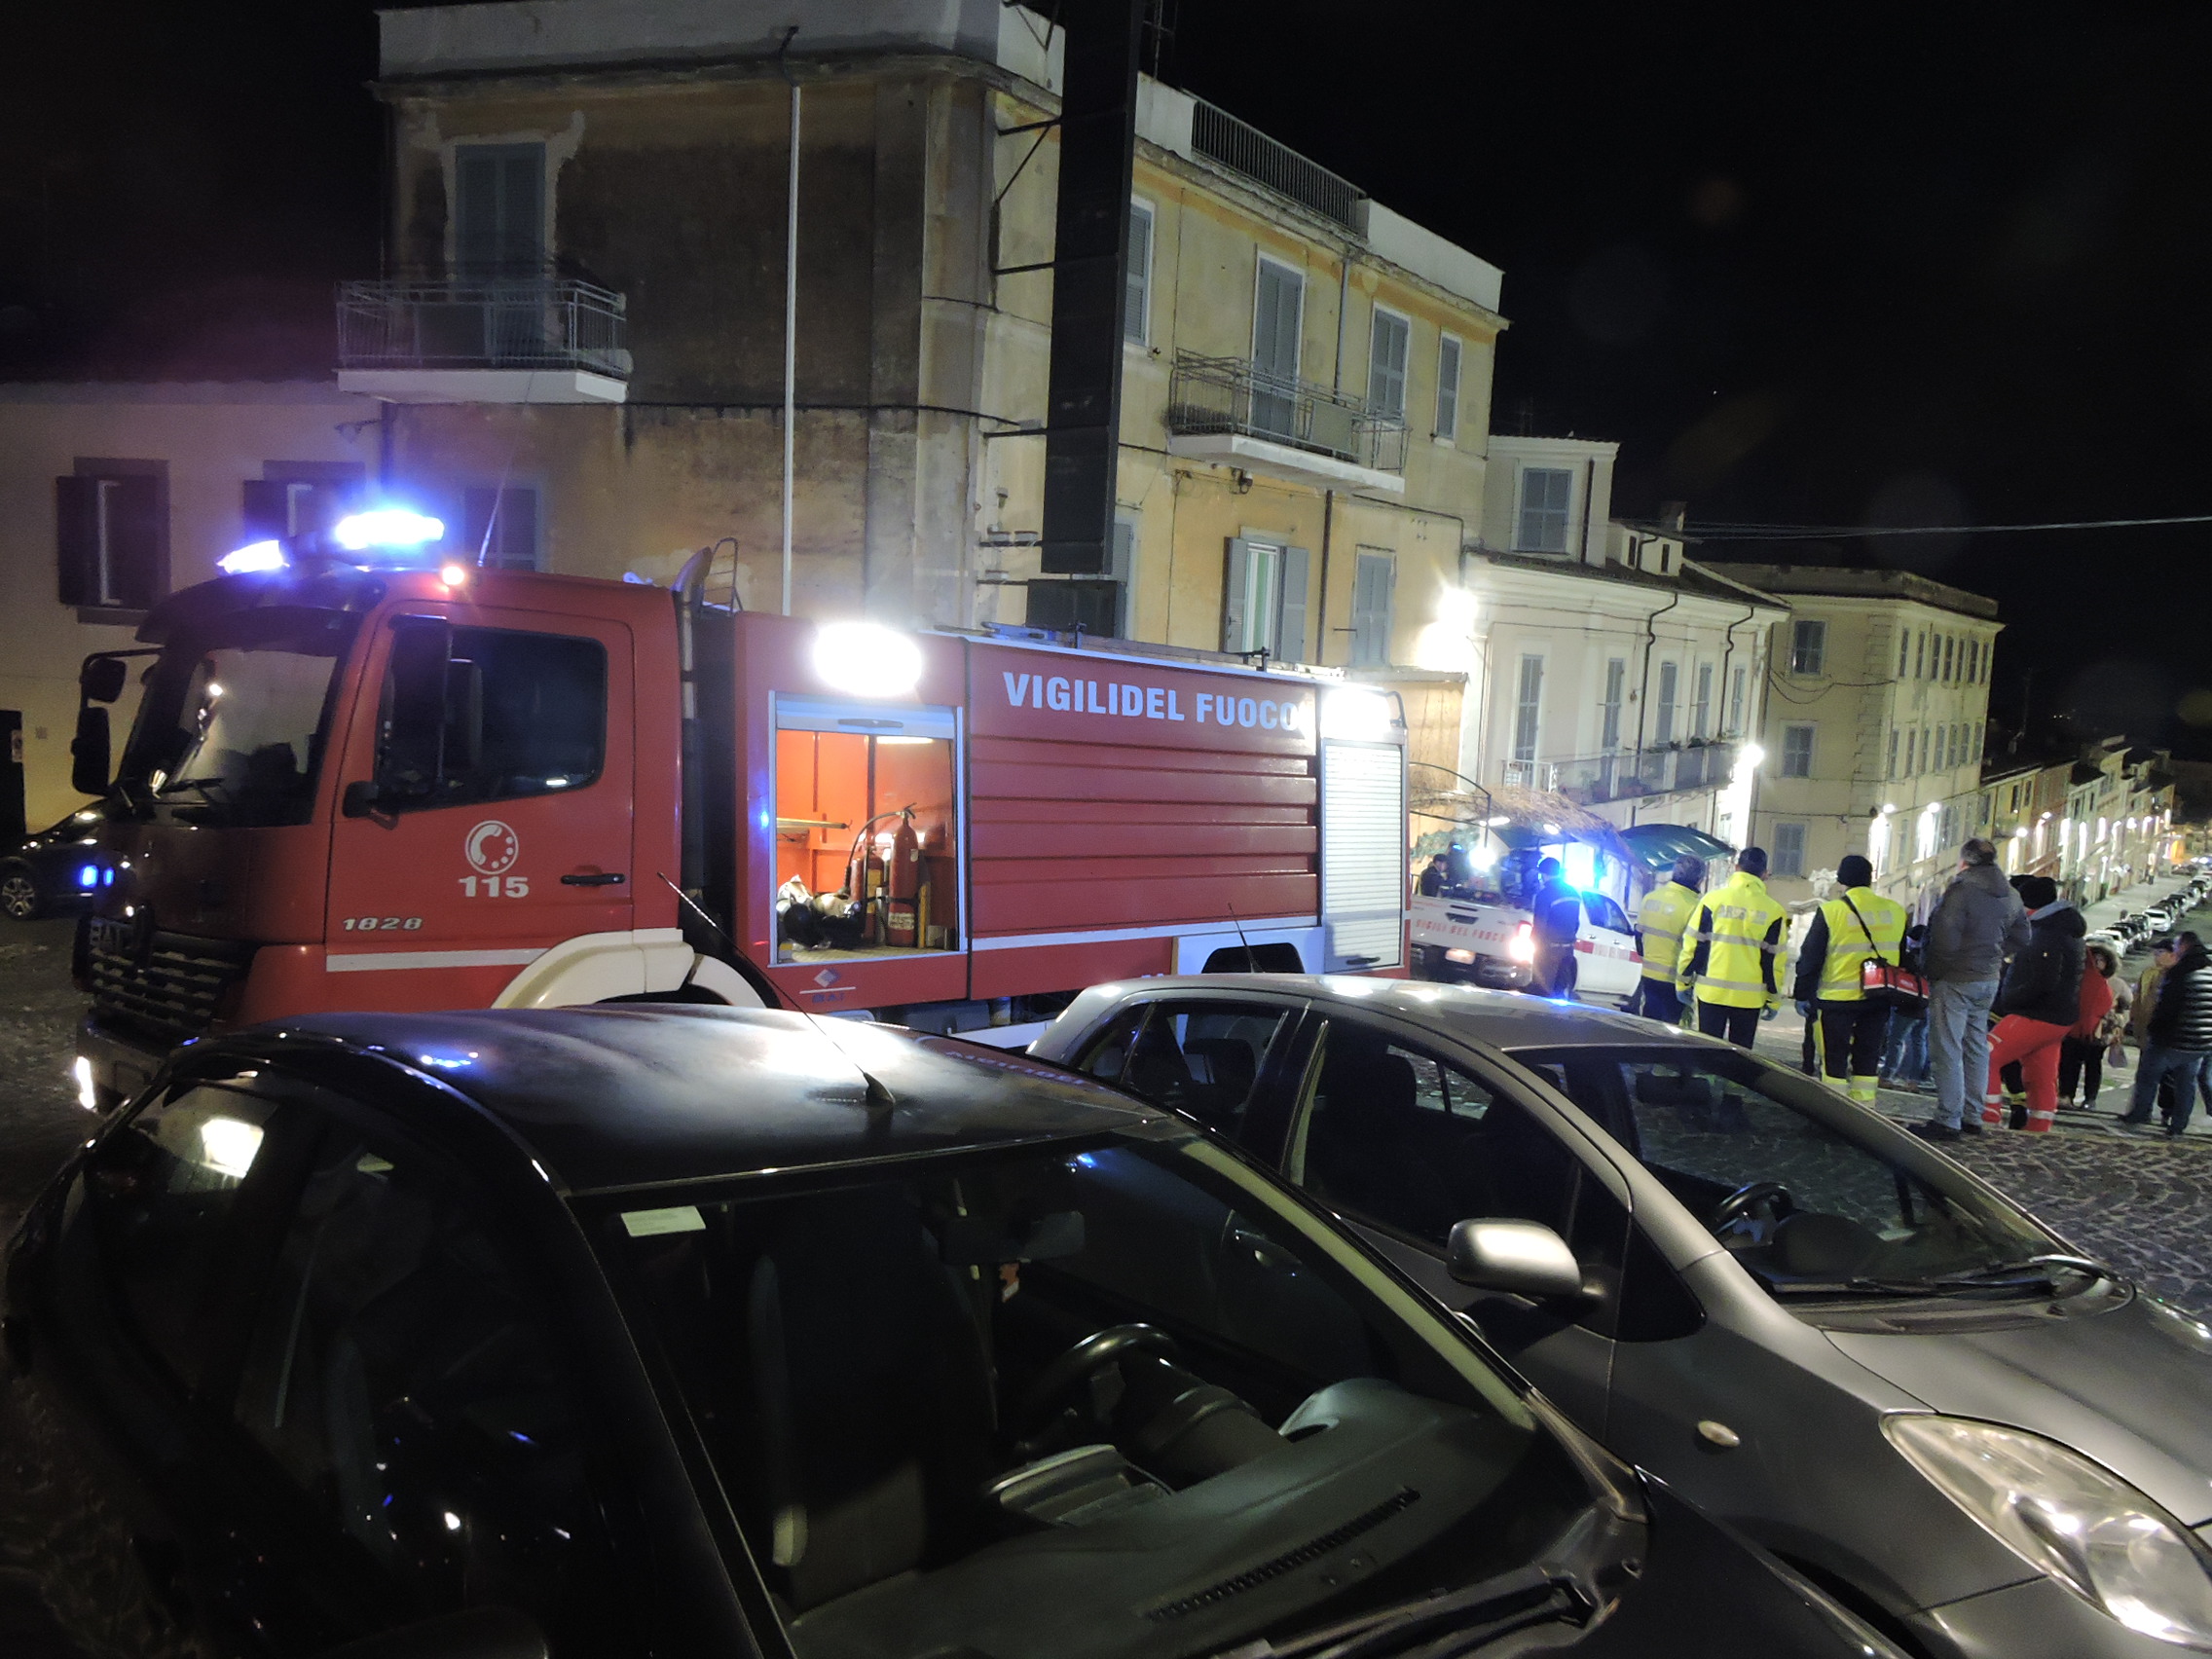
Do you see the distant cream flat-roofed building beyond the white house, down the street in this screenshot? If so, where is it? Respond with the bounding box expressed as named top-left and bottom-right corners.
top-left (1723, 562), bottom-right (2002, 916)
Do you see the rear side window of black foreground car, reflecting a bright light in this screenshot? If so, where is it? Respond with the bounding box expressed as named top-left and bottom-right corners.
top-left (84, 1084), bottom-right (281, 1387)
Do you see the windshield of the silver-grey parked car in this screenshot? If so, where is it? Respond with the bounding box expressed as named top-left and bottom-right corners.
top-left (1513, 1044), bottom-right (2059, 1296)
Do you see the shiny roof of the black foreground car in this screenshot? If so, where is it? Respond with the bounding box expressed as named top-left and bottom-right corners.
top-left (224, 1004), bottom-right (1165, 1195)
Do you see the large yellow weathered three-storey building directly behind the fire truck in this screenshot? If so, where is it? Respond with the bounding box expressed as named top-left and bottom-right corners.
top-left (341, 0), bottom-right (1504, 723)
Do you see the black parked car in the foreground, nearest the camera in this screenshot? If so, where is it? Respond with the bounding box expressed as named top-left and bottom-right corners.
top-left (0, 1009), bottom-right (1898, 1659)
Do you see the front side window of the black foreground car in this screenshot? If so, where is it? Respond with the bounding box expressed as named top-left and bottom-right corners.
top-left (233, 1120), bottom-right (624, 1654)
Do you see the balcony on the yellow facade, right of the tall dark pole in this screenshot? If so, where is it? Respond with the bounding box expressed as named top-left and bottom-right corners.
top-left (1168, 351), bottom-right (1405, 496)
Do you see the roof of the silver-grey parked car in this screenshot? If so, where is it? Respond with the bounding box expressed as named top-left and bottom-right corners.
top-left (1088, 974), bottom-right (1710, 1049)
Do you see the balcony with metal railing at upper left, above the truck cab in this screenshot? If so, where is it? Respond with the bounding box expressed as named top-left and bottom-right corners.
top-left (339, 276), bottom-right (631, 403)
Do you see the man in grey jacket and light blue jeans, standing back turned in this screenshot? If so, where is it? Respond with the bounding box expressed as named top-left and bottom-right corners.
top-left (1913, 838), bottom-right (2026, 1141)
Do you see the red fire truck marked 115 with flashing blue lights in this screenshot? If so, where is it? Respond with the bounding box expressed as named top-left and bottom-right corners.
top-left (75, 544), bottom-right (1407, 1106)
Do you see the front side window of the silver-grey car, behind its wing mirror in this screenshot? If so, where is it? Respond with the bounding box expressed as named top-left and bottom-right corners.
top-left (1290, 1019), bottom-right (1581, 1247)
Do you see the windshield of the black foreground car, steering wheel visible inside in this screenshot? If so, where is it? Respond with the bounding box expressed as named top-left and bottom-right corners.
top-left (602, 1128), bottom-right (1593, 1659)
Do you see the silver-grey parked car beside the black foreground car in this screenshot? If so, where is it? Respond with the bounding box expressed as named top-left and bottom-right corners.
top-left (1031, 974), bottom-right (2212, 1659)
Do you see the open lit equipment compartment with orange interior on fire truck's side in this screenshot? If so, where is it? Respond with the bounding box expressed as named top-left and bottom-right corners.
top-left (774, 697), bottom-right (960, 962)
